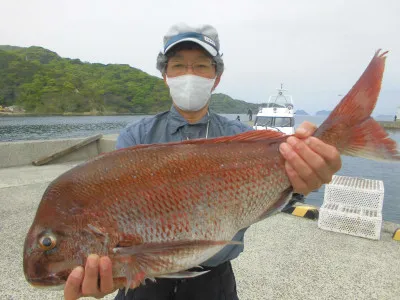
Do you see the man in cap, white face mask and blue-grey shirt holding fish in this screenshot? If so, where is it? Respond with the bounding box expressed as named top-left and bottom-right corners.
top-left (64, 24), bottom-right (341, 300)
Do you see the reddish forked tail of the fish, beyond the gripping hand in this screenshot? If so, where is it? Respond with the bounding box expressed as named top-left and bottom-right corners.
top-left (314, 50), bottom-right (400, 160)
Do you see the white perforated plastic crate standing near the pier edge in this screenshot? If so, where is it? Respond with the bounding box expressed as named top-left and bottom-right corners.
top-left (318, 175), bottom-right (384, 240)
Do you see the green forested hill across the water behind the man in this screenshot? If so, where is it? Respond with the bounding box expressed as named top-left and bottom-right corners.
top-left (0, 45), bottom-right (258, 114)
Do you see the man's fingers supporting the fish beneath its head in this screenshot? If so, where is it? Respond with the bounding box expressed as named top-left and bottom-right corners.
top-left (64, 254), bottom-right (115, 300)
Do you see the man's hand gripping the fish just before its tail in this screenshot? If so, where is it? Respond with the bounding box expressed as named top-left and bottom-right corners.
top-left (279, 121), bottom-right (342, 195)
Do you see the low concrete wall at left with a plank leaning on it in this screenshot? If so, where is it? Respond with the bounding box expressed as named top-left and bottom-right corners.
top-left (0, 135), bottom-right (117, 168)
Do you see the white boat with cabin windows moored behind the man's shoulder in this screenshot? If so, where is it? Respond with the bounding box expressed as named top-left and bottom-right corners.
top-left (253, 84), bottom-right (296, 134)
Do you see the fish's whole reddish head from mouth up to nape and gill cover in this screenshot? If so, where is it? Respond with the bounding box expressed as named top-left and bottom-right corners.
top-left (23, 173), bottom-right (114, 287)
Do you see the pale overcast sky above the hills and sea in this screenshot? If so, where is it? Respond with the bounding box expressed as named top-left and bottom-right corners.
top-left (0, 0), bottom-right (400, 114)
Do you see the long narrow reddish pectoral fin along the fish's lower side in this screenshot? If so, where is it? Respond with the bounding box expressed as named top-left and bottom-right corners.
top-left (113, 240), bottom-right (242, 255)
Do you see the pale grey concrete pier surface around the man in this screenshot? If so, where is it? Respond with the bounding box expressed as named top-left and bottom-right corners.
top-left (0, 136), bottom-right (400, 300)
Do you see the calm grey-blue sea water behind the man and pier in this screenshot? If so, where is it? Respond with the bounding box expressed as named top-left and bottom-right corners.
top-left (0, 114), bottom-right (400, 223)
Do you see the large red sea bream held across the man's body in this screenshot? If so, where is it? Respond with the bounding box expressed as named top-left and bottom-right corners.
top-left (24, 51), bottom-right (400, 287)
